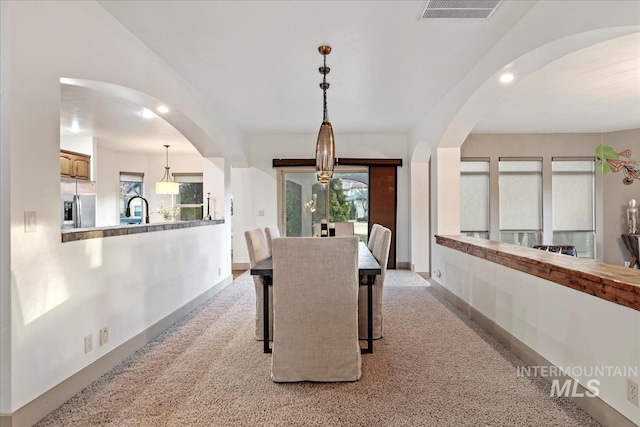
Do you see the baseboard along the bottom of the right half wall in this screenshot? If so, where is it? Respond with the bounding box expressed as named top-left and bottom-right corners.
top-left (430, 280), bottom-right (637, 427)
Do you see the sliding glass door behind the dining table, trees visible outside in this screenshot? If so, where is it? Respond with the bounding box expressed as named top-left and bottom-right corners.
top-left (279, 168), bottom-right (369, 242)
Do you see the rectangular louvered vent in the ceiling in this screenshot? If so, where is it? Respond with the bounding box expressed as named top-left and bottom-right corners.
top-left (420, 0), bottom-right (502, 20)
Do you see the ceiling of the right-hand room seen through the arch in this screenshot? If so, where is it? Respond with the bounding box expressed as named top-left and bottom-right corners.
top-left (473, 33), bottom-right (640, 133)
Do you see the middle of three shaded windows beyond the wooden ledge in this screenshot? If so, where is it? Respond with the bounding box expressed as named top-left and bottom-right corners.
top-left (498, 158), bottom-right (542, 247)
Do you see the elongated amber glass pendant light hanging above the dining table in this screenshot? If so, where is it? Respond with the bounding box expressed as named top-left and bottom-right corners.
top-left (316, 46), bottom-right (336, 185)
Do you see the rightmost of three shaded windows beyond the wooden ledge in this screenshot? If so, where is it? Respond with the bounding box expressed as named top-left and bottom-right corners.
top-left (551, 158), bottom-right (595, 258)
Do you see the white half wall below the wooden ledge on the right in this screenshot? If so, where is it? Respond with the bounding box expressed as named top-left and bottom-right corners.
top-left (434, 245), bottom-right (640, 425)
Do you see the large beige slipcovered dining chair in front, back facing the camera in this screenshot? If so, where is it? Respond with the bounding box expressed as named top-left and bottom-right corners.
top-left (271, 237), bottom-right (361, 382)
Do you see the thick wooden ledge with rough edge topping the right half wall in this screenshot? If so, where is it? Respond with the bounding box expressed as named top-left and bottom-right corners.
top-left (436, 235), bottom-right (640, 311)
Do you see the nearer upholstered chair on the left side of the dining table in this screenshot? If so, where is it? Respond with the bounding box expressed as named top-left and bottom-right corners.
top-left (244, 228), bottom-right (273, 341)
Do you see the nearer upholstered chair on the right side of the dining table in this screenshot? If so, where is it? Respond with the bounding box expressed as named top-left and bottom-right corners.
top-left (358, 225), bottom-right (391, 339)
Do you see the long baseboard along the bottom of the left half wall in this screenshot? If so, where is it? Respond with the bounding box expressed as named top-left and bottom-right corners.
top-left (0, 276), bottom-right (233, 427)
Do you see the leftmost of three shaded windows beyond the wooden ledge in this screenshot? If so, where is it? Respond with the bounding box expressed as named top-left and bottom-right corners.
top-left (460, 159), bottom-right (489, 239)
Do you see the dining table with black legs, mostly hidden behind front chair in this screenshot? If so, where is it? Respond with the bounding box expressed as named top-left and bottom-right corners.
top-left (251, 241), bottom-right (382, 354)
